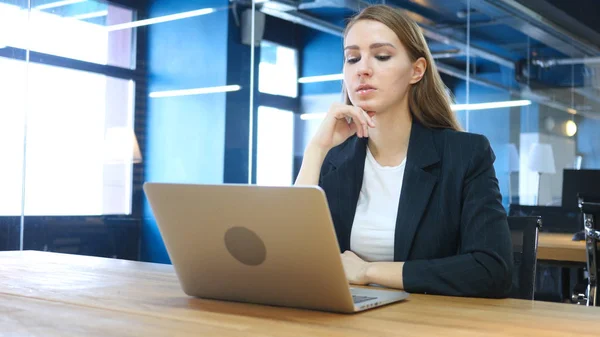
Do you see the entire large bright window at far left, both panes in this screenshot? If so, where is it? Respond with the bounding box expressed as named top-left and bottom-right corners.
top-left (0, 0), bottom-right (141, 216)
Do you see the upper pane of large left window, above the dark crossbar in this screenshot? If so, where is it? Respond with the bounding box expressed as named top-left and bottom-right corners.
top-left (0, 0), bottom-right (135, 68)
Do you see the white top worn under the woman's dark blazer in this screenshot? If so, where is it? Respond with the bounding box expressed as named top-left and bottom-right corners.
top-left (350, 147), bottom-right (406, 262)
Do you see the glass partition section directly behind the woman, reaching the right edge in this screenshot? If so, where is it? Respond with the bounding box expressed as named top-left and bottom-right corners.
top-left (247, 0), bottom-right (600, 210)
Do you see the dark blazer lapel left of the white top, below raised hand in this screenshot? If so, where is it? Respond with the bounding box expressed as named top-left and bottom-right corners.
top-left (330, 137), bottom-right (368, 251)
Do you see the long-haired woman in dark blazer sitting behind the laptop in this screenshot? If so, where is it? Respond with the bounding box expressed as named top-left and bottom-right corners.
top-left (296, 5), bottom-right (512, 297)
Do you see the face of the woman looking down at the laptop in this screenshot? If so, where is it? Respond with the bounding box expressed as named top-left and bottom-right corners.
top-left (344, 20), bottom-right (425, 115)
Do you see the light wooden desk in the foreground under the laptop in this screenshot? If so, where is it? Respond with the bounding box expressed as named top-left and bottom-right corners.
top-left (0, 252), bottom-right (600, 337)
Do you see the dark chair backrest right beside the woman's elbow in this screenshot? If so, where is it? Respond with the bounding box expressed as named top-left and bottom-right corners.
top-left (508, 216), bottom-right (542, 300)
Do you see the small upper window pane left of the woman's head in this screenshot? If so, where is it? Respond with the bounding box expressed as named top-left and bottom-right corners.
top-left (258, 41), bottom-right (298, 97)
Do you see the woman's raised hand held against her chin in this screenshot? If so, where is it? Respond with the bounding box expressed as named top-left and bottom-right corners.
top-left (310, 103), bottom-right (375, 152)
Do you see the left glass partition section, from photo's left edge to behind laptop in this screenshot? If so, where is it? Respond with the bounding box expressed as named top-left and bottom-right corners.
top-left (0, 0), bottom-right (252, 263)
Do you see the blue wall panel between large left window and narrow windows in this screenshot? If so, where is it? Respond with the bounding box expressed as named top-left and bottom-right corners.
top-left (141, 0), bottom-right (229, 263)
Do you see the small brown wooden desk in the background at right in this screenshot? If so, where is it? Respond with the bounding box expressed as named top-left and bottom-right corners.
top-left (537, 233), bottom-right (586, 263)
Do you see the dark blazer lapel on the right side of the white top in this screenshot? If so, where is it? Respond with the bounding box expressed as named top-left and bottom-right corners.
top-left (394, 121), bottom-right (440, 261)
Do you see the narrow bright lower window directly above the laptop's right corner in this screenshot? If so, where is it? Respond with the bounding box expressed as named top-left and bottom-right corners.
top-left (256, 106), bottom-right (294, 186)
